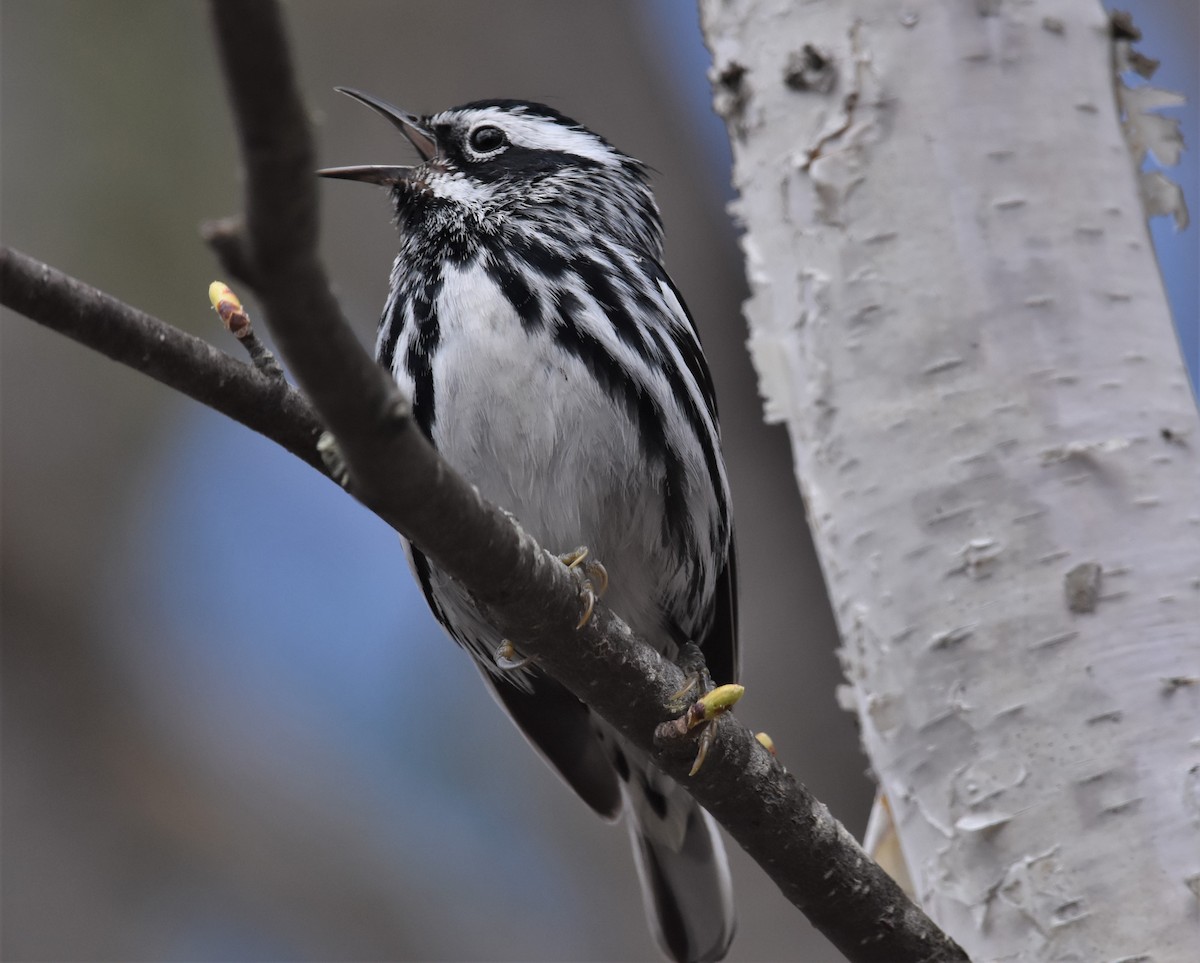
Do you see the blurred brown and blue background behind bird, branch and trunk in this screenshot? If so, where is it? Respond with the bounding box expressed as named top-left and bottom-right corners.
top-left (0, 0), bottom-right (1200, 961)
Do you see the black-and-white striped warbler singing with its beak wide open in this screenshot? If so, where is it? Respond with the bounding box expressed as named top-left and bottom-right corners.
top-left (322, 90), bottom-right (737, 961)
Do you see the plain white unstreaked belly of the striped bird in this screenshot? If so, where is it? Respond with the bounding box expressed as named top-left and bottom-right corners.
top-left (412, 262), bottom-right (691, 651)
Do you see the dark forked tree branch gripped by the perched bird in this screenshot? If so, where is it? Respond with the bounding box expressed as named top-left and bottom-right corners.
top-left (0, 0), bottom-right (966, 963)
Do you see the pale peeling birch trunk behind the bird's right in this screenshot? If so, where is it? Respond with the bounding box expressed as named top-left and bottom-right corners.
top-left (701, 0), bottom-right (1200, 962)
